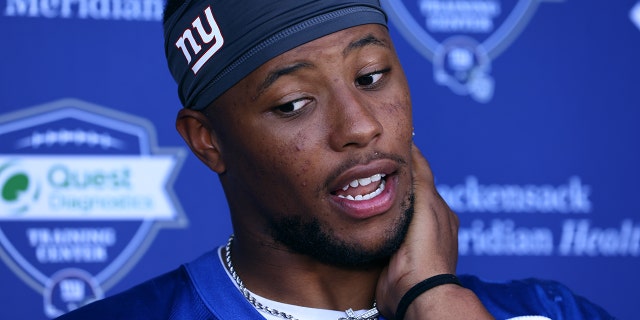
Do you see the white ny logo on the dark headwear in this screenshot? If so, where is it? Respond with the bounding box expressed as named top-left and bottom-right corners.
top-left (176, 6), bottom-right (224, 74)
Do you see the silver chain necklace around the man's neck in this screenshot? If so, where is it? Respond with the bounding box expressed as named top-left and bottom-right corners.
top-left (225, 235), bottom-right (379, 320)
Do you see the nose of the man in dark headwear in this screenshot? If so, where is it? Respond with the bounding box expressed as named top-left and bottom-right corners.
top-left (328, 88), bottom-right (383, 151)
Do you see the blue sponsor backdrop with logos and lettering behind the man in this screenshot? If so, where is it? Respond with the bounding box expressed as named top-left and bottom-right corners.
top-left (0, 0), bottom-right (640, 319)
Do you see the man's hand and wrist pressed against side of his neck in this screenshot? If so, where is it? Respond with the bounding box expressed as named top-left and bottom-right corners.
top-left (376, 145), bottom-right (493, 320)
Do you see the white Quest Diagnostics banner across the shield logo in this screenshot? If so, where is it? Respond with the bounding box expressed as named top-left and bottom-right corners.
top-left (0, 155), bottom-right (174, 220)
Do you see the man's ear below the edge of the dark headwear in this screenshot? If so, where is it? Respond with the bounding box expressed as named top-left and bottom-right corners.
top-left (176, 108), bottom-right (225, 173)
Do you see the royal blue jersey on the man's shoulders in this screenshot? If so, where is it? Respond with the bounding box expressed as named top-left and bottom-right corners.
top-left (58, 250), bottom-right (614, 320)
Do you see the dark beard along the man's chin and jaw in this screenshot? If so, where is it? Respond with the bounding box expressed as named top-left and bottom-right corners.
top-left (271, 190), bottom-right (414, 269)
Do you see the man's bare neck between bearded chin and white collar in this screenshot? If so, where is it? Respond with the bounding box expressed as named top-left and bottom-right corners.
top-left (231, 232), bottom-right (381, 310)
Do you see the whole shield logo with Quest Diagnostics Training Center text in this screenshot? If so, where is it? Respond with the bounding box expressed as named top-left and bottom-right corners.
top-left (0, 99), bottom-right (187, 318)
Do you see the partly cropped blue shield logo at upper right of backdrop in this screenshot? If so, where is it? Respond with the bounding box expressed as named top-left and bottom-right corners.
top-left (382, 0), bottom-right (563, 103)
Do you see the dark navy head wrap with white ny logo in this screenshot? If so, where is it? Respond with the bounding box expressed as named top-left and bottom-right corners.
top-left (164, 0), bottom-right (387, 110)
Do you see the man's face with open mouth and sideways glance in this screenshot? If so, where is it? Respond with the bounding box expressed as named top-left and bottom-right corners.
top-left (207, 25), bottom-right (412, 266)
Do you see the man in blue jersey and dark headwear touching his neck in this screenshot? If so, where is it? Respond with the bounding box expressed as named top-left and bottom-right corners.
top-left (57, 0), bottom-right (610, 319)
